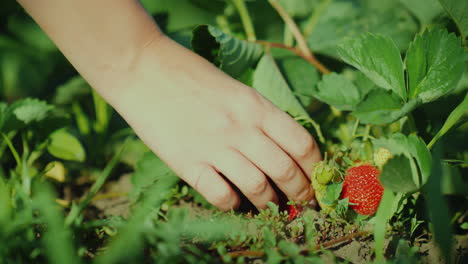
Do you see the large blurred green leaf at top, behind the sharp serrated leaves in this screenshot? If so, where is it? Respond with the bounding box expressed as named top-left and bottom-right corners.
top-left (307, 1), bottom-right (418, 58)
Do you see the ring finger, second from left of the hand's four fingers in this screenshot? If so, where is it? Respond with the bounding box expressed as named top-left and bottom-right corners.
top-left (214, 150), bottom-right (278, 209)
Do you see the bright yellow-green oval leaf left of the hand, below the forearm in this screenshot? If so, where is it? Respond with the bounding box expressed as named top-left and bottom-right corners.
top-left (47, 129), bottom-right (86, 162)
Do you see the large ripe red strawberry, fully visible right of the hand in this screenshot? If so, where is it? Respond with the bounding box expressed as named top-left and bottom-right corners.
top-left (341, 164), bottom-right (383, 215)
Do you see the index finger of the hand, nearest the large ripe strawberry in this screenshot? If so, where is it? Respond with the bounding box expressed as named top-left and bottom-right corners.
top-left (263, 111), bottom-right (322, 177)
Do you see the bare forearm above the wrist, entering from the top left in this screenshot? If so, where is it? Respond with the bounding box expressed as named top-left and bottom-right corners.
top-left (18, 0), bottom-right (162, 94)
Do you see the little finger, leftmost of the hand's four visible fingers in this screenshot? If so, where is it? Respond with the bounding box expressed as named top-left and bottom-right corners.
top-left (183, 164), bottom-right (240, 211)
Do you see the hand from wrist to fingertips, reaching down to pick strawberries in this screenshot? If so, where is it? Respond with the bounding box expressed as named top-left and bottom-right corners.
top-left (105, 37), bottom-right (321, 210)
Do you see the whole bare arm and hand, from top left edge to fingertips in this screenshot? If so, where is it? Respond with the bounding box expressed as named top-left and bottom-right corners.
top-left (18, 0), bottom-right (321, 210)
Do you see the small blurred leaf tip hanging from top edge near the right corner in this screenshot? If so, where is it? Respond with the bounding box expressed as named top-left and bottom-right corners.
top-left (400, 0), bottom-right (444, 25)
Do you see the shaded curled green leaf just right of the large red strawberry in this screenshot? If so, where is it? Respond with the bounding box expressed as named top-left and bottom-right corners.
top-left (379, 155), bottom-right (418, 193)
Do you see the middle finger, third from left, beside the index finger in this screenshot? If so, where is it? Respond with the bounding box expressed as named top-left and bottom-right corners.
top-left (241, 131), bottom-right (314, 201)
